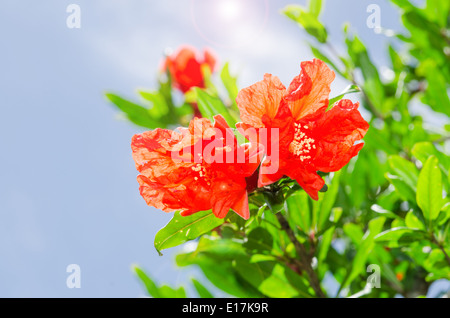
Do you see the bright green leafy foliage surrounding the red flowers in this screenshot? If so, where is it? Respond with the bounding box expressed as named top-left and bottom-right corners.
top-left (107, 0), bottom-right (450, 298)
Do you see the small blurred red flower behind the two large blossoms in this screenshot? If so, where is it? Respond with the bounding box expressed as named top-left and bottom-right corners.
top-left (164, 46), bottom-right (216, 93)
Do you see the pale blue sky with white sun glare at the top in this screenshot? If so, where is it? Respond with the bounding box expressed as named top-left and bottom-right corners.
top-left (0, 0), bottom-right (414, 297)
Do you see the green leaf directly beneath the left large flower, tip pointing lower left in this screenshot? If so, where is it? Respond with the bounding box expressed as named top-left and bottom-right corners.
top-left (155, 211), bottom-right (224, 252)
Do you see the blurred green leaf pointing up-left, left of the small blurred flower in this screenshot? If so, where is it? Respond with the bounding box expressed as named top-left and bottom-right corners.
top-left (106, 93), bottom-right (159, 129)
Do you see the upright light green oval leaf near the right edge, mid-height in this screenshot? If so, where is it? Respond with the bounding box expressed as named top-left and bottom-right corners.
top-left (417, 156), bottom-right (443, 224)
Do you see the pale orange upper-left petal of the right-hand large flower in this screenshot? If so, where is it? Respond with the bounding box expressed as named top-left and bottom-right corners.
top-left (236, 74), bottom-right (286, 128)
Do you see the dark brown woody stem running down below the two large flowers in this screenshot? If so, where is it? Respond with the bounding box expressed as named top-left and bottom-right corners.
top-left (276, 213), bottom-right (326, 298)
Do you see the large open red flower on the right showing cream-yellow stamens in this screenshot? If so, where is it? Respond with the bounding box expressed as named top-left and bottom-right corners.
top-left (236, 59), bottom-right (369, 200)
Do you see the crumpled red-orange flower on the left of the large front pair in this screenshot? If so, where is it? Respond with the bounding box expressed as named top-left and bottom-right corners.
top-left (131, 115), bottom-right (262, 219)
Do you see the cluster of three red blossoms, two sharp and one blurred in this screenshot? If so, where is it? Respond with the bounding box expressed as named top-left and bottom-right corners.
top-left (131, 48), bottom-right (369, 219)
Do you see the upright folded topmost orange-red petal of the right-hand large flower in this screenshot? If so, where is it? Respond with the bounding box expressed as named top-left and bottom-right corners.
top-left (286, 59), bottom-right (335, 120)
